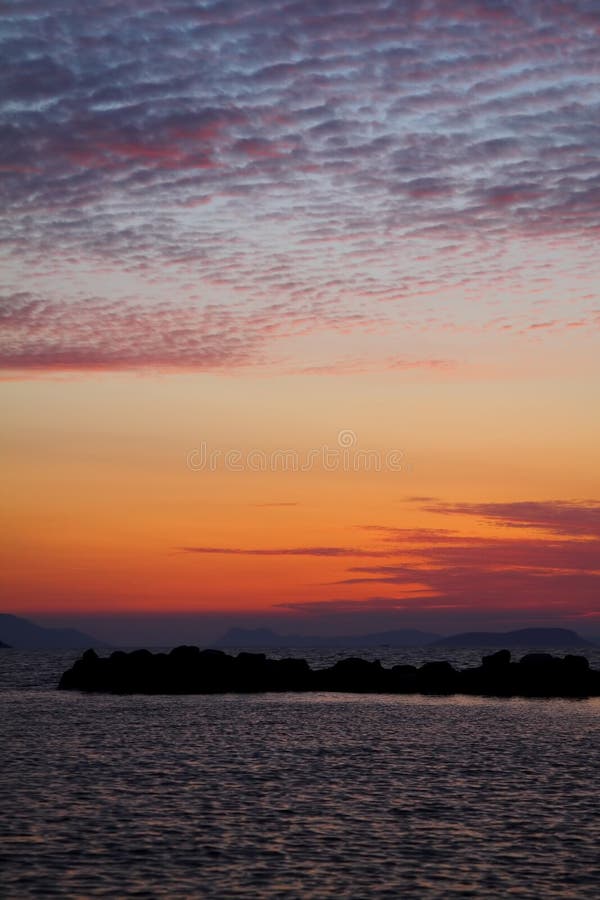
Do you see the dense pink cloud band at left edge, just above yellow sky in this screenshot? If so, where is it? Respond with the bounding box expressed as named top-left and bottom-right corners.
top-left (0, 292), bottom-right (390, 370)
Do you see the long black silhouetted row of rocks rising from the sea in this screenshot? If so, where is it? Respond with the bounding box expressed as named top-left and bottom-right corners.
top-left (58, 646), bottom-right (600, 697)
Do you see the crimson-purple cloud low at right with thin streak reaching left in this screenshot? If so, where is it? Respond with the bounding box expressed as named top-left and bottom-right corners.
top-left (180, 498), bottom-right (600, 621)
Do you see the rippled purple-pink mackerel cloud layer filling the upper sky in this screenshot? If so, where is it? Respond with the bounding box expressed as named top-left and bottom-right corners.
top-left (0, 0), bottom-right (600, 373)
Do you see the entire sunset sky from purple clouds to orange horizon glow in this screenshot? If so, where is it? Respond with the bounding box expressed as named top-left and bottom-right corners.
top-left (0, 0), bottom-right (600, 642)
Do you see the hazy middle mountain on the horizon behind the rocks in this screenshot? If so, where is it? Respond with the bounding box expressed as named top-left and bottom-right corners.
top-left (214, 628), bottom-right (438, 649)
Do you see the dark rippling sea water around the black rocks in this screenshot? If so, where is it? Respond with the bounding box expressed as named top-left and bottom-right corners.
top-left (0, 651), bottom-right (600, 900)
